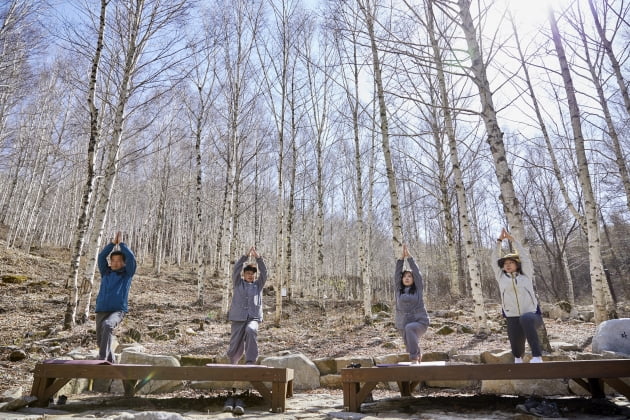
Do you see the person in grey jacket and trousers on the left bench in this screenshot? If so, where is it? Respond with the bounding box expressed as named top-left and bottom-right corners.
top-left (227, 247), bottom-right (267, 365)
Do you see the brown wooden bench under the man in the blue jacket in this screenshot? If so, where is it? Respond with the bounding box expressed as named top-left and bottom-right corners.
top-left (31, 360), bottom-right (293, 413)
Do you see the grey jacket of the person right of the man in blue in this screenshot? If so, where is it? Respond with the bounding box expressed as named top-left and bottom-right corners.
top-left (228, 255), bottom-right (267, 321)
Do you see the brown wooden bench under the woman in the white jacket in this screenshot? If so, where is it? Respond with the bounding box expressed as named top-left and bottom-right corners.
top-left (341, 359), bottom-right (630, 412)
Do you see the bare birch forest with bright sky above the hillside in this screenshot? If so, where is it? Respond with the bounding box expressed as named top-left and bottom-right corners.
top-left (0, 0), bottom-right (630, 330)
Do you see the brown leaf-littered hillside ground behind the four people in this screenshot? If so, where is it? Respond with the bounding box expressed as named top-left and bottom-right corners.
top-left (0, 241), bottom-right (616, 392)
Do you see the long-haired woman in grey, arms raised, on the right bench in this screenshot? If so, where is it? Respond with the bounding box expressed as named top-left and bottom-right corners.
top-left (394, 245), bottom-right (429, 364)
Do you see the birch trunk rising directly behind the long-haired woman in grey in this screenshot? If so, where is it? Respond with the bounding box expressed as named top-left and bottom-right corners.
top-left (357, 0), bottom-right (403, 256)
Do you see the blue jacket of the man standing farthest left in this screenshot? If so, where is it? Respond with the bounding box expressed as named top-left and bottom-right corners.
top-left (95, 242), bottom-right (136, 312)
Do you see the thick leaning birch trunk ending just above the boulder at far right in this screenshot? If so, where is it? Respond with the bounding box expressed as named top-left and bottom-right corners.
top-left (548, 9), bottom-right (608, 325)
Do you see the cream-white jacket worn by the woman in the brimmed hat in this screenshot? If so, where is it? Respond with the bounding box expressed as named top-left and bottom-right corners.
top-left (492, 241), bottom-right (538, 316)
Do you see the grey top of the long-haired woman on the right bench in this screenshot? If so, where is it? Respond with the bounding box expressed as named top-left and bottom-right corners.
top-left (394, 257), bottom-right (429, 329)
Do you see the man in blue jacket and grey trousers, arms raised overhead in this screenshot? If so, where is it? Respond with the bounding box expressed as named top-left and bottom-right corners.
top-left (95, 232), bottom-right (136, 363)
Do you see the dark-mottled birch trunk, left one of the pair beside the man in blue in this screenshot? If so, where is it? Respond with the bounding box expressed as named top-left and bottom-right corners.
top-left (64, 0), bottom-right (108, 330)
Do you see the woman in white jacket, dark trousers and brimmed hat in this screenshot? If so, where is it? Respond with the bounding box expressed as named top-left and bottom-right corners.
top-left (494, 229), bottom-right (543, 363)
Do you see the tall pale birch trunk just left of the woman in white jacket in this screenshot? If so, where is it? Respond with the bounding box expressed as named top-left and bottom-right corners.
top-left (427, 0), bottom-right (487, 332)
